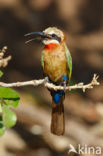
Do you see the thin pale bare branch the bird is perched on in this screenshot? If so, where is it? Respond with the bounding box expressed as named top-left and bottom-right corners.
top-left (0, 74), bottom-right (100, 92)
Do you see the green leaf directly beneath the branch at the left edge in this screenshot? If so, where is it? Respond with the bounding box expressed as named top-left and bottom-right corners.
top-left (0, 87), bottom-right (20, 99)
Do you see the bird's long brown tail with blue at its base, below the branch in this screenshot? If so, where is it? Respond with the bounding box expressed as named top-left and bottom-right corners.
top-left (51, 91), bottom-right (65, 135)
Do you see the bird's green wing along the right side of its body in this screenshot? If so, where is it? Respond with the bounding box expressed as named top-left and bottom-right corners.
top-left (64, 44), bottom-right (72, 81)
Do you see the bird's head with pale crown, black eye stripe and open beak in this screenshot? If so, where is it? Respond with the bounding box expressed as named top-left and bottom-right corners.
top-left (25, 27), bottom-right (65, 45)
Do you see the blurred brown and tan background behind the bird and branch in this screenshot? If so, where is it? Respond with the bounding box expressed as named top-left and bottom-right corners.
top-left (0, 0), bottom-right (103, 156)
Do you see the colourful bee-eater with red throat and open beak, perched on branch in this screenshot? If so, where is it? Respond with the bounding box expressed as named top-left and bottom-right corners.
top-left (25, 27), bottom-right (72, 136)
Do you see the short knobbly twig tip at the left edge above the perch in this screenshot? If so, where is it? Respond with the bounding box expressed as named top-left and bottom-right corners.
top-left (0, 46), bottom-right (11, 67)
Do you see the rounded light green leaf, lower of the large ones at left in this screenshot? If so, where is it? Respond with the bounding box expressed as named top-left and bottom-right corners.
top-left (2, 104), bottom-right (17, 128)
